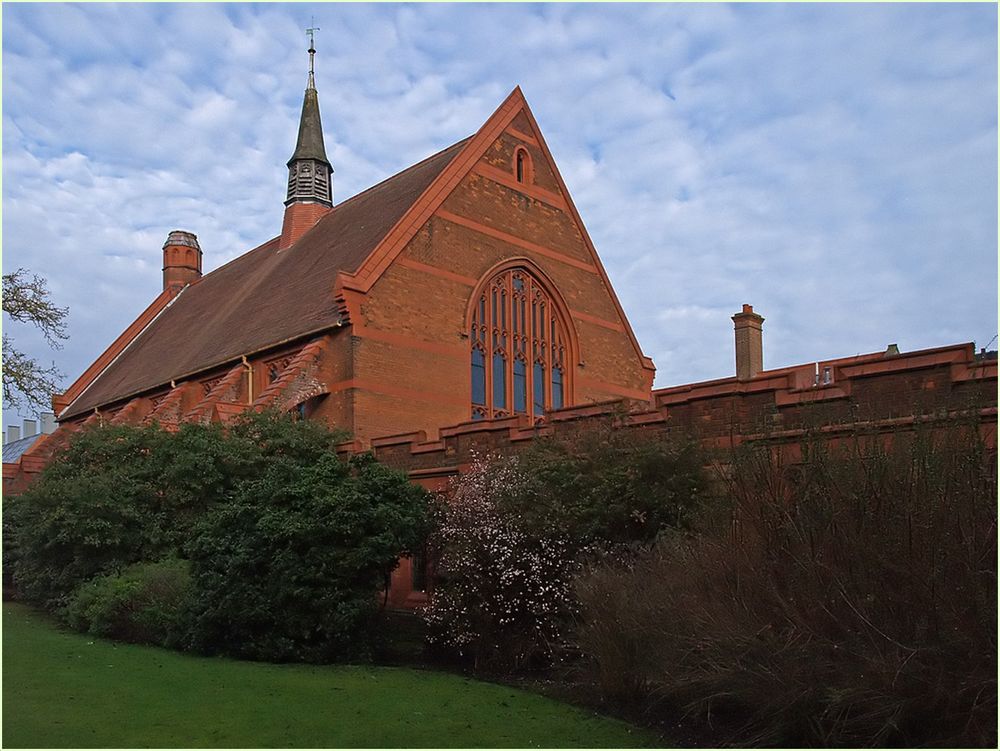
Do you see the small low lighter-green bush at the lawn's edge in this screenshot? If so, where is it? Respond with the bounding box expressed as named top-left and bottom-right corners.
top-left (64, 558), bottom-right (190, 646)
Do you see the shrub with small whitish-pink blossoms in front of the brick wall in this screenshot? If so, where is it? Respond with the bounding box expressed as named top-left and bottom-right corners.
top-left (424, 456), bottom-right (577, 671)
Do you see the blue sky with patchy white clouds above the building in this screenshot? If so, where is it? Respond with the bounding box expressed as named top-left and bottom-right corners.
top-left (2, 3), bottom-right (997, 425)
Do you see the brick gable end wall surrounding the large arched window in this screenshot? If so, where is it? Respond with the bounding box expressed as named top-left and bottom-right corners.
top-left (352, 116), bottom-right (650, 442)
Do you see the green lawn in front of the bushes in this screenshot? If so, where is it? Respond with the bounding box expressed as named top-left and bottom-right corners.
top-left (3, 603), bottom-right (656, 748)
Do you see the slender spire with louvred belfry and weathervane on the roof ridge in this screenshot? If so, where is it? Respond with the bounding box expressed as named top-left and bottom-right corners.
top-left (278, 27), bottom-right (333, 250)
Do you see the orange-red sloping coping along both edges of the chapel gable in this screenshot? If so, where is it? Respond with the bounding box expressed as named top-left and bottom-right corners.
top-left (335, 86), bottom-right (655, 388)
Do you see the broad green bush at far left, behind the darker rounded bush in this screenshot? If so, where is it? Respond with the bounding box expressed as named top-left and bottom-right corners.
top-left (4, 412), bottom-right (343, 608)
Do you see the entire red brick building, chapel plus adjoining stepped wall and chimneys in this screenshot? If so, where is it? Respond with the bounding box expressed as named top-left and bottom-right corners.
top-left (4, 49), bottom-right (997, 605)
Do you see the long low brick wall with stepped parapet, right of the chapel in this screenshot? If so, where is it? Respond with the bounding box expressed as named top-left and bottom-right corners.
top-left (358, 344), bottom-right (997, 489)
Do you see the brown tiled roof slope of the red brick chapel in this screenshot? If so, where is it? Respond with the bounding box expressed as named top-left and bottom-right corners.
top-left (66, 139), bottom-right (468, 419)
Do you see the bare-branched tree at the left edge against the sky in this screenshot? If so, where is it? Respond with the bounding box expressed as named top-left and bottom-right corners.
top-left (3, 269), bottom-right (69, 409)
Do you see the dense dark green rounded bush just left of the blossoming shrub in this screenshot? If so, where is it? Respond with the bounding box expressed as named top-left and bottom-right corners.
top-left (187, 444), bottom-right (429, 662)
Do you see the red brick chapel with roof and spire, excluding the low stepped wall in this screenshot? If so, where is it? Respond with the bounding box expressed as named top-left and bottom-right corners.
top-left (39, 50), bottom-right (653, 446)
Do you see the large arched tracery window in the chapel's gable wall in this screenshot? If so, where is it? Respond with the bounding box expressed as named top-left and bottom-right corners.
top-left (469, 267), bottom-right (570, 420)
